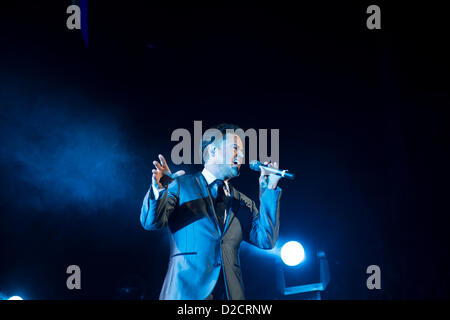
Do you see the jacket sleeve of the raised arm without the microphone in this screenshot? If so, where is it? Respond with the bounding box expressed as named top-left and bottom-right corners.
top-left (141, 179), bottom-right (180, 230)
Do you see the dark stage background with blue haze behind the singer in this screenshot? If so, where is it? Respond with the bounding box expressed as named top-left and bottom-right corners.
top-left (0, 1), bottom-right (450, 299)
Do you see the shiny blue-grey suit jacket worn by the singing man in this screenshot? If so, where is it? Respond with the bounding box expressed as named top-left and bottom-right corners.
top-left (141, 172), bottom-right (281, 300)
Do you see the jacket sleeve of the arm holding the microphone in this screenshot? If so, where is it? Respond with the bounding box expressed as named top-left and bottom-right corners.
top-left (246, 187), bottom-right (282, 249)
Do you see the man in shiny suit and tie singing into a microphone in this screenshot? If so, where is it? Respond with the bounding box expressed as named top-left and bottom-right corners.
top-left (141, 124), bottom-right (281, 300)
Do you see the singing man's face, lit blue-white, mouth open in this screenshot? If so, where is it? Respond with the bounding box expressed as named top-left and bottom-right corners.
top-left (212, 133), bottom-right (244, 179)
